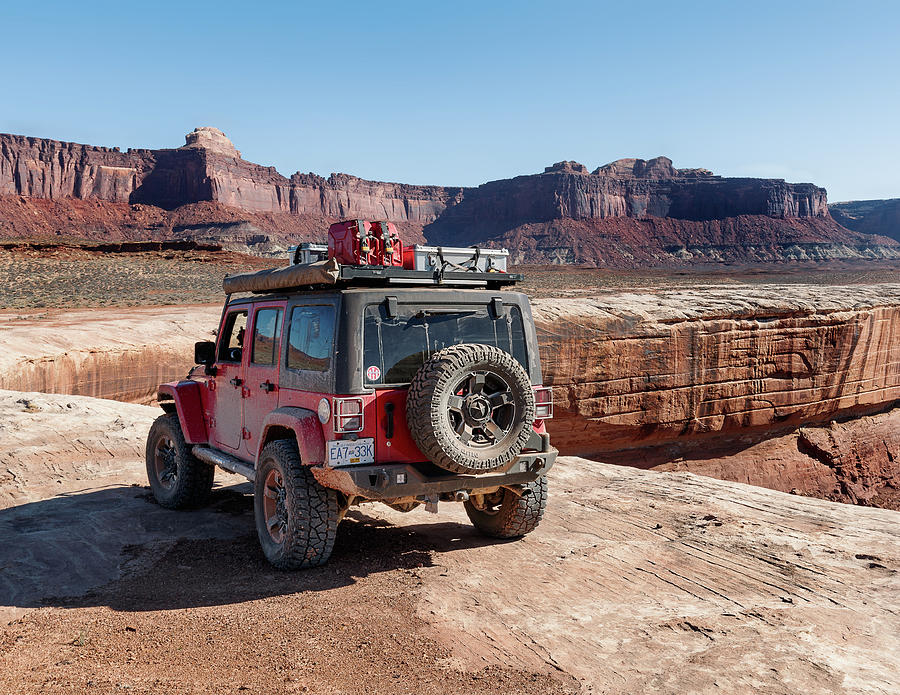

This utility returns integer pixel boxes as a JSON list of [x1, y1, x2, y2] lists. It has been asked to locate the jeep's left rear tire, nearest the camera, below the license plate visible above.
[[253, 439, 340, 570]]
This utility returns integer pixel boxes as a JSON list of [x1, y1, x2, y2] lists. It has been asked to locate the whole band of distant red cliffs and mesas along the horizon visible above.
[[0, 128, 900, 266]]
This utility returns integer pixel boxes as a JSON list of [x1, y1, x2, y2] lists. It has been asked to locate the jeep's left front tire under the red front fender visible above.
[[146, 413, 216, 509]]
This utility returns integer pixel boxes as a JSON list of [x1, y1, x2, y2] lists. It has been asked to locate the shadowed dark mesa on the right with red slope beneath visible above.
[[423, 157, 900, 267]]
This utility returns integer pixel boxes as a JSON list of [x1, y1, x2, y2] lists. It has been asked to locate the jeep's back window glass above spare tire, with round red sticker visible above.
[[363, 304, 528, 386]]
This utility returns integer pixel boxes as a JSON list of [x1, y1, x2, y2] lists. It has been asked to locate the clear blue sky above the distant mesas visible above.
[[0, 0, 900, 201]]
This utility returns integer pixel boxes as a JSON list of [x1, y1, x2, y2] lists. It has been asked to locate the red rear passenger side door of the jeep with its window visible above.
[[243, 301, 285, 458]]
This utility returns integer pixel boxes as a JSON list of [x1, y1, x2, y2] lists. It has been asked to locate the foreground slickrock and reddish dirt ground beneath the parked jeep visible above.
[[0, 391, 900, 694]]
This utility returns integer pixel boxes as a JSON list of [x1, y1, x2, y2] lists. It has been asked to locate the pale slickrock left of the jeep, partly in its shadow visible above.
[[0, 390, 243, 624]]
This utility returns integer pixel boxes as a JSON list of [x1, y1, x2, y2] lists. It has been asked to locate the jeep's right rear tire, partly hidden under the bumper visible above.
[[463, 476, 547, 538]]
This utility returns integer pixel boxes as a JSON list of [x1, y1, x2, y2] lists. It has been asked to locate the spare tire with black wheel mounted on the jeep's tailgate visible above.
[[406, 344, 534, 474]]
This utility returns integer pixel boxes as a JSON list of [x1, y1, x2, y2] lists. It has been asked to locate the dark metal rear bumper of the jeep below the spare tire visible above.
[[310, 446, 559, 500]]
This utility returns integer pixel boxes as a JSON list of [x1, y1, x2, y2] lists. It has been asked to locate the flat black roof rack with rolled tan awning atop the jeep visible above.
[[222, 258, 522, 294]]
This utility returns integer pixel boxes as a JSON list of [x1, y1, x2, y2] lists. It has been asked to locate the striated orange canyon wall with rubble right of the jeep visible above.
[[534, 284, 900, 507]]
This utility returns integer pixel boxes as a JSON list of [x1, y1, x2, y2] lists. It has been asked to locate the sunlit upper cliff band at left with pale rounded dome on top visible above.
[[0, 128, 462, 225]]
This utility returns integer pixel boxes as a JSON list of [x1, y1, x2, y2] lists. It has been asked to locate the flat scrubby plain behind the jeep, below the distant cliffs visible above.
[[0, 242, 900, 309]]
